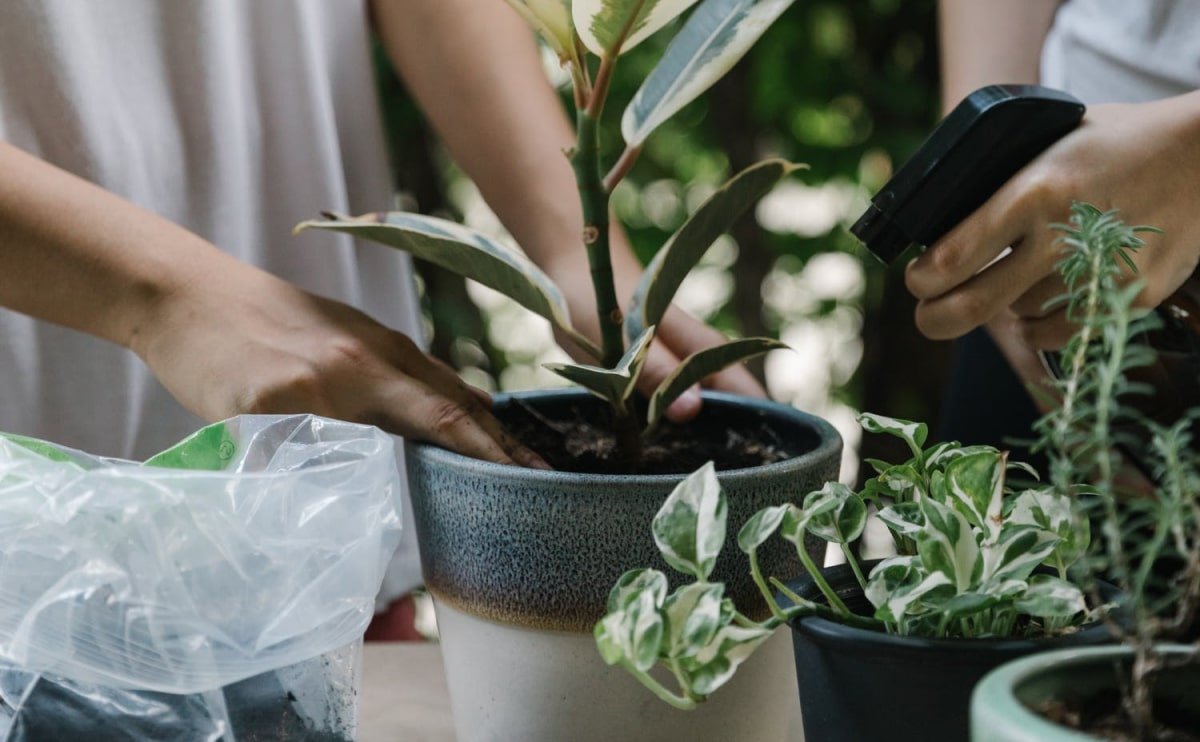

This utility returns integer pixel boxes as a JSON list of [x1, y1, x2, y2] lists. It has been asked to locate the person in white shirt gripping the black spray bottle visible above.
[[906, 0, 1200, 445]]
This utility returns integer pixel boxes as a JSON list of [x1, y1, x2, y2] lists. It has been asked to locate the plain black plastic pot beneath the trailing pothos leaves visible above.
[[792, 562, 1110, 742]]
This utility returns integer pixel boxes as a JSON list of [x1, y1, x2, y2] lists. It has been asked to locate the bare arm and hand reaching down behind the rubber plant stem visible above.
[[373, 0, 761, 419]]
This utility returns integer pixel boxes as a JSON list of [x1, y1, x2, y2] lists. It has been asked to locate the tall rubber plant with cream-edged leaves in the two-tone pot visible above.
[[298, 0, 799, 460]]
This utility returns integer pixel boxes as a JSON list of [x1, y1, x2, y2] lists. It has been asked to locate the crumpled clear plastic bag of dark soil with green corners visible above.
[[0, 415, 401, 741]]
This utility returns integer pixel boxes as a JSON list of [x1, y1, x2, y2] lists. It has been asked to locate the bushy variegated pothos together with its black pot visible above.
[[594, 414, 1106, 741]]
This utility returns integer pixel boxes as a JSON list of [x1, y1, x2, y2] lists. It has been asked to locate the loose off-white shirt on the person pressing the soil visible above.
[[0, 0, 429, 592]]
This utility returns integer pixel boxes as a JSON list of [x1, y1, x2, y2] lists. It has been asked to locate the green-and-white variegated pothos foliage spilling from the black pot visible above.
[[595, 414, 1090, 708]]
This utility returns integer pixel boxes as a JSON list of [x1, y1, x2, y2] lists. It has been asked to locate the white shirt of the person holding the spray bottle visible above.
[[1042, 0, 1200, 103]]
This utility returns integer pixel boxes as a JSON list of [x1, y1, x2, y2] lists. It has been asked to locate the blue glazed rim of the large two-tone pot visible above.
[[406, 389, 842, 486]]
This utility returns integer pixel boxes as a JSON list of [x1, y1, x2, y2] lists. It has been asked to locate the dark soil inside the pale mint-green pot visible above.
[[1033, 689, 1200, 742]]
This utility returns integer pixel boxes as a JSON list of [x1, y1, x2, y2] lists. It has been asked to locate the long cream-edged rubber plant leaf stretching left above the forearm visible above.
[[295, 211, 600, 358]]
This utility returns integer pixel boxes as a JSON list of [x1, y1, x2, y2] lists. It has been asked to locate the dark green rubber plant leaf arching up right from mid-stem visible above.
[[625, 160, 800, 337]]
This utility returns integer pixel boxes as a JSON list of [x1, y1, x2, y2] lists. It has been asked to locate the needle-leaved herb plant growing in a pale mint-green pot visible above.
[[972, 204, 1200, 742]]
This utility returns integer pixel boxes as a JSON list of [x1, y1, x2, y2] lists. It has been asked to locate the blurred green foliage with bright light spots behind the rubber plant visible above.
[[380, 0, 949, 480]]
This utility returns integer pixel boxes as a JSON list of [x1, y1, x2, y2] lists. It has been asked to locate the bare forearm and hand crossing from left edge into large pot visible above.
[[0, 142, 544, 466]]
